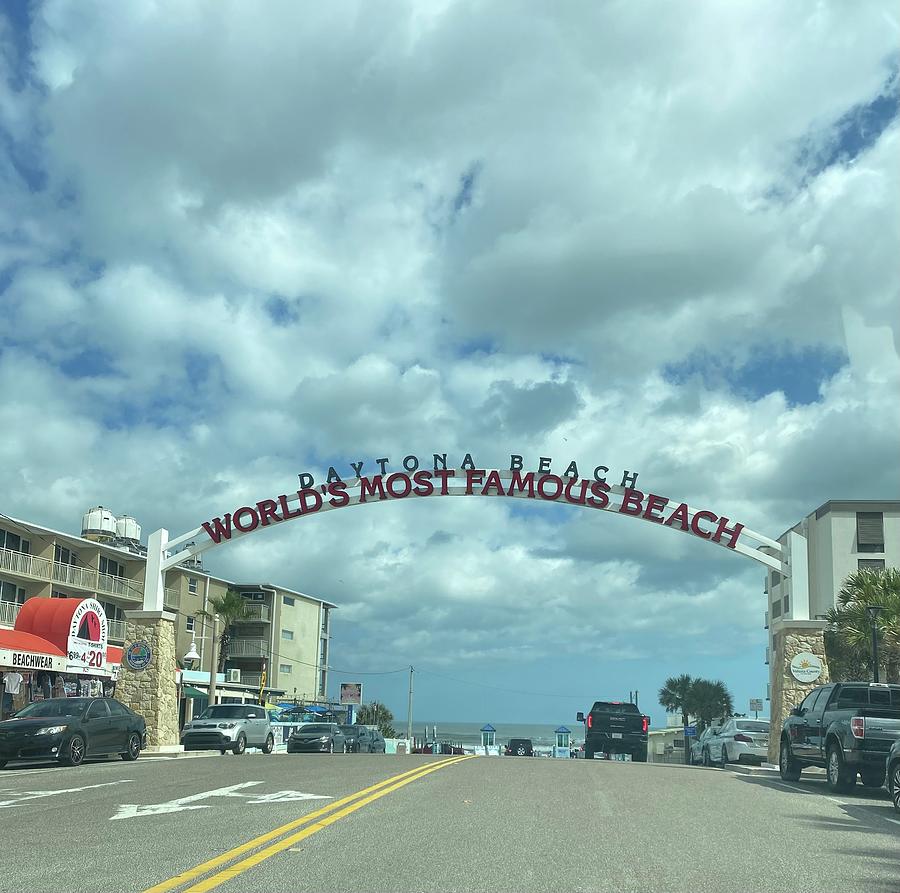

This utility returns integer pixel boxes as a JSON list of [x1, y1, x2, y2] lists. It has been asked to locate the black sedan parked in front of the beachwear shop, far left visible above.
[[0, 698, 147, 769]]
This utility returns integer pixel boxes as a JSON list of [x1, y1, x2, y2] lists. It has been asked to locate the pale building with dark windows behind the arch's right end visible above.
[[765, 500, 900, 692]]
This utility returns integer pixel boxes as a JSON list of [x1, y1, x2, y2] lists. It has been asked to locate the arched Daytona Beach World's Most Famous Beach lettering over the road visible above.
[[202, 453, 744, 549]]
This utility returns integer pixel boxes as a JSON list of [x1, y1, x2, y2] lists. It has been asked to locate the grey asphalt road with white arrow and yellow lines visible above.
[[0, 754, 900, 893]]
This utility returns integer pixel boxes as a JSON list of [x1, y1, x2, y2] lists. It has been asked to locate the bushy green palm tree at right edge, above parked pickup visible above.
[[825, 568, 900, 683]]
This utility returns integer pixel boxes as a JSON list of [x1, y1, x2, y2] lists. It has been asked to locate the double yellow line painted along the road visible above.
[[143, 756, 472, 893]]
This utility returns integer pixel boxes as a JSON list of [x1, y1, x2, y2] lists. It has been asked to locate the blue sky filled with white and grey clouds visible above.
[[0, 0, 900, 722]]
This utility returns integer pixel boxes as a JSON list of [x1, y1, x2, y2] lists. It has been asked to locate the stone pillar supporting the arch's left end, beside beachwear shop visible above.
[[116, 611, 179, 750]]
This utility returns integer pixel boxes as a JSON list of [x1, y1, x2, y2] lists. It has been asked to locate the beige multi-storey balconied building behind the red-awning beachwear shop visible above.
[[0, 508, 335, 700]]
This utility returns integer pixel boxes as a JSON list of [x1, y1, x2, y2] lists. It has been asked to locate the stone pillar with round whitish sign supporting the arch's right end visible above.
[[769, 620, 830, 765]]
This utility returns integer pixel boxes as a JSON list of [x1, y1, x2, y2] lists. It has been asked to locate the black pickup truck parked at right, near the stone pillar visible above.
[[778, 682, 900, 792]]
